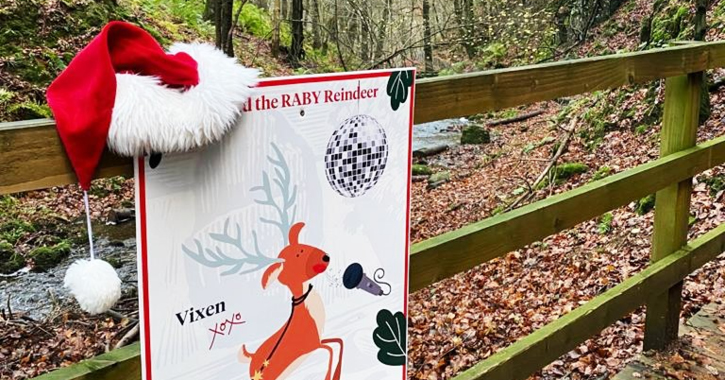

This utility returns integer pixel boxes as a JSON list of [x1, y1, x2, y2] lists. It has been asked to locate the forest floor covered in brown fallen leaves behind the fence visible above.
[[0, 0, 725, 380]]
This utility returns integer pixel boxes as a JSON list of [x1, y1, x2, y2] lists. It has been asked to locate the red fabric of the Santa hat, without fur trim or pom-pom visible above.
[[47, 22, 199, 190]]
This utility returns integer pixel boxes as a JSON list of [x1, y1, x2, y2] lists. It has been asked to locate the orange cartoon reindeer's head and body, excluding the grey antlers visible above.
[[239, 223, 343, 380]]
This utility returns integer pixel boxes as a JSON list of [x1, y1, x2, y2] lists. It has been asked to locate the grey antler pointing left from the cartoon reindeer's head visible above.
[[181, 218, 279, 276]]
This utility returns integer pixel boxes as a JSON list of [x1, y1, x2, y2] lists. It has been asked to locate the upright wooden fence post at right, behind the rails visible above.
[[644, 72, 702, 350]]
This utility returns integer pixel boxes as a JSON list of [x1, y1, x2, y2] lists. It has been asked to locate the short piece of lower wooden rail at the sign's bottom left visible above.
[[35, 342, 141, 380]]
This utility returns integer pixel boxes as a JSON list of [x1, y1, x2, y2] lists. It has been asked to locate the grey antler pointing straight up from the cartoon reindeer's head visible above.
[[251, 143, 297, 246]]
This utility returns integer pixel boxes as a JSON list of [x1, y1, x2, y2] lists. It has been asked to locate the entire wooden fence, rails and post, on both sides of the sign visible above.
[[0, 42, 725, 380]]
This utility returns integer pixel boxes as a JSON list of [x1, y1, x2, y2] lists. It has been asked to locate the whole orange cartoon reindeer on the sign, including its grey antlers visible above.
[[182, 144, 343, 380]]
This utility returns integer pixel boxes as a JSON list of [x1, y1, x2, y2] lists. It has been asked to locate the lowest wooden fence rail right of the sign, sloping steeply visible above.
[[446, 224, 725, 380]]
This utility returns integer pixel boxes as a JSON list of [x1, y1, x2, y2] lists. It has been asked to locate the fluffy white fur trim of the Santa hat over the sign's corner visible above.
[[107, 43, 259, 156]]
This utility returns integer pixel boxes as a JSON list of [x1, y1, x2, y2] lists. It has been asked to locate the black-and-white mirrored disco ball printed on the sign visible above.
[[325, 115, 388, 198]]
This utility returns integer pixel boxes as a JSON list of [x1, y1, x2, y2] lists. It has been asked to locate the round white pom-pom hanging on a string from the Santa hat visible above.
[[64, 259, 121, 314]]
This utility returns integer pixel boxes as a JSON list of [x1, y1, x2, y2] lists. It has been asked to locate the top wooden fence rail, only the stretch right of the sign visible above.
[[415, 42, 725, 123]]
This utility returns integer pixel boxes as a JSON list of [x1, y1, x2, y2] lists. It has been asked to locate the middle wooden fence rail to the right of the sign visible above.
[[410, 136, 725, 291]]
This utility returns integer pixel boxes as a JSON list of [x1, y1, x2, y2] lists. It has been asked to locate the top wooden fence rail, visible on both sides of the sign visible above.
[[0, 42, 725, 194]]
